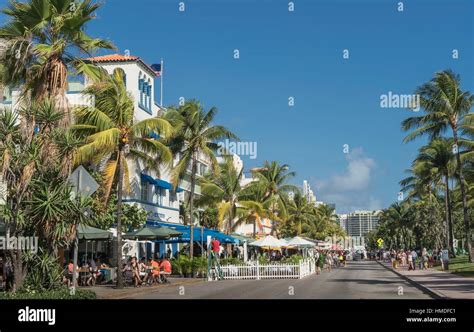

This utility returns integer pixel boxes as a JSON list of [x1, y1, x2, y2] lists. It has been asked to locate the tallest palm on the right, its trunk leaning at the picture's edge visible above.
[[402, 70, 474, 262]]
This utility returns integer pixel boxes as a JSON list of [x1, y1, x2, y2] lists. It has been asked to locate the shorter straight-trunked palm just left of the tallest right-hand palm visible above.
[[415, 138, 456, 255]]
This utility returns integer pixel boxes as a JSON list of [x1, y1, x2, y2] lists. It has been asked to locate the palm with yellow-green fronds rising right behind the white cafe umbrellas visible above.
[[253, 161, 298, 234]]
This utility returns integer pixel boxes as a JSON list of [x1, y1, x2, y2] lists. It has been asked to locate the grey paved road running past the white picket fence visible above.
[[131, 261, 431, 299]]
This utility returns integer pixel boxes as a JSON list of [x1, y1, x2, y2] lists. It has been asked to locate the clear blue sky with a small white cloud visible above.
[[0, 0, 474, 212]]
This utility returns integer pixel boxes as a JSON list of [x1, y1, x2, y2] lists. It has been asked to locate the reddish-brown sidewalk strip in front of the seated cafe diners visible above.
[[90, 278, 204, 300]]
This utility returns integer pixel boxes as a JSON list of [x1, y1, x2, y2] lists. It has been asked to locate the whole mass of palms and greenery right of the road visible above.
[[371, 70, 474, 262]]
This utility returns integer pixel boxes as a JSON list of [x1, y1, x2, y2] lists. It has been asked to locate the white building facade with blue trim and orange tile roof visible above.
[[0, 54, 213, 227]]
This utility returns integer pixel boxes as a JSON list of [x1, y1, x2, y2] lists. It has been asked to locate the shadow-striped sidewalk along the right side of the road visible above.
[[377, 261, 474, 300]]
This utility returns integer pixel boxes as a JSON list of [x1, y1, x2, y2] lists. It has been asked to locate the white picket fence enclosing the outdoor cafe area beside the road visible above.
[[221, 259, 316, 280]]
